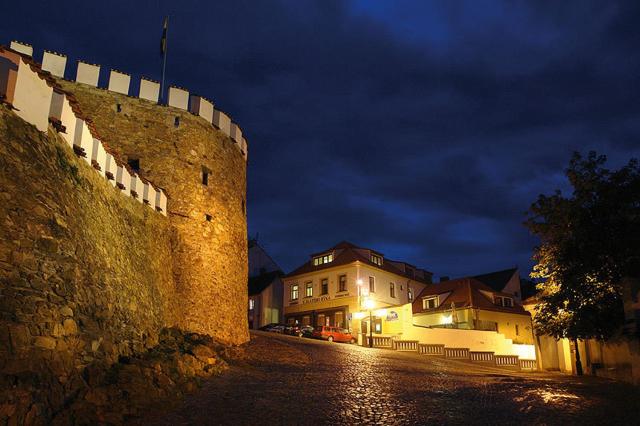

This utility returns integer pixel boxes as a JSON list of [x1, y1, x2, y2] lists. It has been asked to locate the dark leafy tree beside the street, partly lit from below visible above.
[[525, 152, 640, 375]]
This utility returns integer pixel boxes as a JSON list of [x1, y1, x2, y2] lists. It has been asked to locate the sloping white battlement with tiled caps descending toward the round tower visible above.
[[0, 42, 167, 216]]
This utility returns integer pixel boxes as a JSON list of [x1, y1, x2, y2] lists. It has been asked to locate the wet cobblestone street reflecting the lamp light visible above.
[[151, 332, 640, 425]]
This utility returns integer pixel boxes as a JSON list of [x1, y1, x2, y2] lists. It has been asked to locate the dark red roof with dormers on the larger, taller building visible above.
[[285, 241, 432, 283]]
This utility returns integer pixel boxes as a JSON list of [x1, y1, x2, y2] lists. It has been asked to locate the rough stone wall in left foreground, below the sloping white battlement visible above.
[[0, 106, 180, 372]]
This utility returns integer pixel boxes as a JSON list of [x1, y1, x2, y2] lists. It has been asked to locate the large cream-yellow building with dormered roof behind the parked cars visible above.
[[283, 242, 432, 334]]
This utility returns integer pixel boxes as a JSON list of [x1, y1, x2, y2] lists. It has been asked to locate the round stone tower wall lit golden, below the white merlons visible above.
[[53, 80, 248, 343]]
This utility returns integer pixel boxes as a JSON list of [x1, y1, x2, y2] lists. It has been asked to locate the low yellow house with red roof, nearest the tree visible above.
[[412, 273, 533, 344]]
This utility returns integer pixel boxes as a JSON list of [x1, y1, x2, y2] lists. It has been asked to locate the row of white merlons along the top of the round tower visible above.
[[10, 41, 248, 160]]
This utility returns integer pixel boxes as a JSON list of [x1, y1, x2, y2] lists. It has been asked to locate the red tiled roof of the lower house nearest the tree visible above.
[[412, 278, 528, 315]]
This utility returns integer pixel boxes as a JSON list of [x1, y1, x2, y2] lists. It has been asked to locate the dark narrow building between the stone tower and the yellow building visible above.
[[248, 240, 284, 329]]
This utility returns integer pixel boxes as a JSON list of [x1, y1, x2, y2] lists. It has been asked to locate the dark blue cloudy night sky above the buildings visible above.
[[0, 0, 640, 277]]
